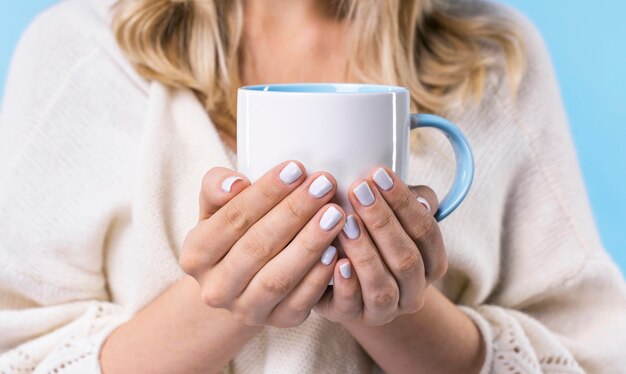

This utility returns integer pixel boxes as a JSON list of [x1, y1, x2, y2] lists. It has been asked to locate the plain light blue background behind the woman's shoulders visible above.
[[0, 0, 626, 270]]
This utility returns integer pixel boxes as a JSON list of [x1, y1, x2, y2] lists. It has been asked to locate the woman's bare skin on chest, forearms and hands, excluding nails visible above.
[[100, 0, 485, 374]]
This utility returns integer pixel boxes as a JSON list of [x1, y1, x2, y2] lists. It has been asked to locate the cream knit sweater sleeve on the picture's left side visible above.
[[0, 1, 144, 373]]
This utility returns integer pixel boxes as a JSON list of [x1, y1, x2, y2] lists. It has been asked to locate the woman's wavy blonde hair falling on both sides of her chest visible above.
[[113, 0, 523, 140]]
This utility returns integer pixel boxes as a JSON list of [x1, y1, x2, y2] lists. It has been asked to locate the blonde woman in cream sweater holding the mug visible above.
[[0, 0, 626, 374]]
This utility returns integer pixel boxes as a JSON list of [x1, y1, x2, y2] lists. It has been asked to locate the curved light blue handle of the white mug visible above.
[[411, 114, 474, 221]]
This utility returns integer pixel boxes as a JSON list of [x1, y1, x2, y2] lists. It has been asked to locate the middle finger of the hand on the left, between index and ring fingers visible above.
[[207, 173, 336, 296]]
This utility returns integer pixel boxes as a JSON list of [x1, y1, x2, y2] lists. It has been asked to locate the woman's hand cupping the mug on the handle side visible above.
[[315, 167, 448, 326]]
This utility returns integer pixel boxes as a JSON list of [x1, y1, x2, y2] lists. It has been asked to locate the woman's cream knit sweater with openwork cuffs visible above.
[[0, 0, 626, 373]]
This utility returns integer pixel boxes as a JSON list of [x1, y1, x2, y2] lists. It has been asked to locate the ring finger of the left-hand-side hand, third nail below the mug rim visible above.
[[234, 204, 345, 319]]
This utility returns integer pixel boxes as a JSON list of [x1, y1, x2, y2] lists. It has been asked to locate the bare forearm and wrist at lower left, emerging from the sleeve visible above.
[[100, 276, 261, 373]]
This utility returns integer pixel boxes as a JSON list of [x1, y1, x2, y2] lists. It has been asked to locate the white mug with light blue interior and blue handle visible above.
[[237, 83, 474, 221]]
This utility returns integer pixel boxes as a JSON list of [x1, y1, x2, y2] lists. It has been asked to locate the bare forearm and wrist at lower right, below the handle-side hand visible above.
[[341, 286, 485, 373]]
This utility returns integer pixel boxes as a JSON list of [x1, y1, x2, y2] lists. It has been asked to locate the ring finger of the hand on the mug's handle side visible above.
[[338, 214, 401, 325]]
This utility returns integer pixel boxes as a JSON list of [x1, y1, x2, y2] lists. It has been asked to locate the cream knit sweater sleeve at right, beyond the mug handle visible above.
[[461, 4, 626, 373]]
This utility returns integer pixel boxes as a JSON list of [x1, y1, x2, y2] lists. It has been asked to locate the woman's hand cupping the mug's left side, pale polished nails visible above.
[[180, 161, 345, 327]]
